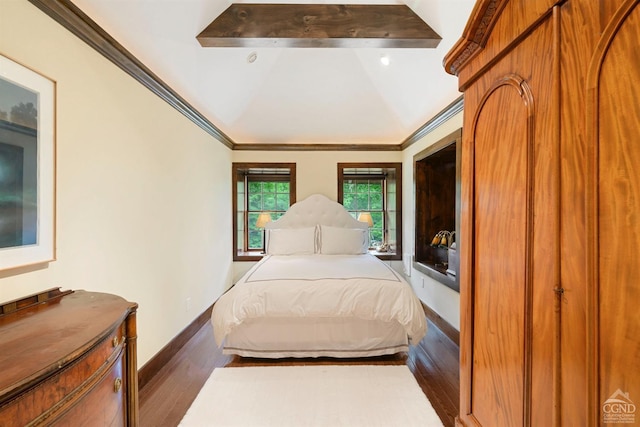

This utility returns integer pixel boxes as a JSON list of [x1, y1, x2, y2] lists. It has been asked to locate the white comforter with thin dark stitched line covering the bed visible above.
[[212, 254, 427, 345]]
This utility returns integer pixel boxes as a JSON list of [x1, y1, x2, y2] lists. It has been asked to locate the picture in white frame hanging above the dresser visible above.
[[0, 55, 55, 270]]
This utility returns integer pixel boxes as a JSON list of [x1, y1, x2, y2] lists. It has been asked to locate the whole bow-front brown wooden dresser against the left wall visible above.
[[0, 288, 138, 427]]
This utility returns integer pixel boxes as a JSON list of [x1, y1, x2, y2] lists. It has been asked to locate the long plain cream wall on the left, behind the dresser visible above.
[[0, 0, 232, 366]]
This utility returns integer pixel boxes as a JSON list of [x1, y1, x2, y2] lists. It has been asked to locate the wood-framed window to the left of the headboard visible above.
[[233, 163, 296, 261]]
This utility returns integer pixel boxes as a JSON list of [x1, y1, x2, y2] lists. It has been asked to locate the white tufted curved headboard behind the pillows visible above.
[[265, 194, 368, 229]]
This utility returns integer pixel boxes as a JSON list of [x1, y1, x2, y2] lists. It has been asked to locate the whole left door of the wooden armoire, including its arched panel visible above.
[[458, 5, 559, 427]]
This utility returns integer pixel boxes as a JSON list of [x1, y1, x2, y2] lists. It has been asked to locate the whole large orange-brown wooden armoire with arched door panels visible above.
[[444, 0, 640, 427]]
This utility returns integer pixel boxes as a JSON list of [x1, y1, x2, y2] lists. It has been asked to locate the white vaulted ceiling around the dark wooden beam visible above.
[[73, 0, 475, 144]]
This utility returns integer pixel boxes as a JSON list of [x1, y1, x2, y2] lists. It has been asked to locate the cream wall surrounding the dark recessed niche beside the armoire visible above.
[[402, 112, 462, 330]]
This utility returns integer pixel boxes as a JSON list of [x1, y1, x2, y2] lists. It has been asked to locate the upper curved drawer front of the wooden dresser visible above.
[[0, 324, 125, 426]]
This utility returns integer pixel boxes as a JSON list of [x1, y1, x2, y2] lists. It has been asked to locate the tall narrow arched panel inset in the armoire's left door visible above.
[[471, 78, 531, 426]]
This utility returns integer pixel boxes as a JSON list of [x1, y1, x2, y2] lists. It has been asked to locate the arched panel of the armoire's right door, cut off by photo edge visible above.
[[585, 0, 640, 425]]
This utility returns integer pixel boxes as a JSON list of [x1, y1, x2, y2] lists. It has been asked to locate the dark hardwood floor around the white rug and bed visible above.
[[139, 322, 460, 427]]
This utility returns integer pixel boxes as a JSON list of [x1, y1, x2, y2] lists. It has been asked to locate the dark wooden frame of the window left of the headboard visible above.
[[231, 162, 296, 261]]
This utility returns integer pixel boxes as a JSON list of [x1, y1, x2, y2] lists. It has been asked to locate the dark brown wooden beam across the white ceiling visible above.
[[196, 3, 442, 48]]
